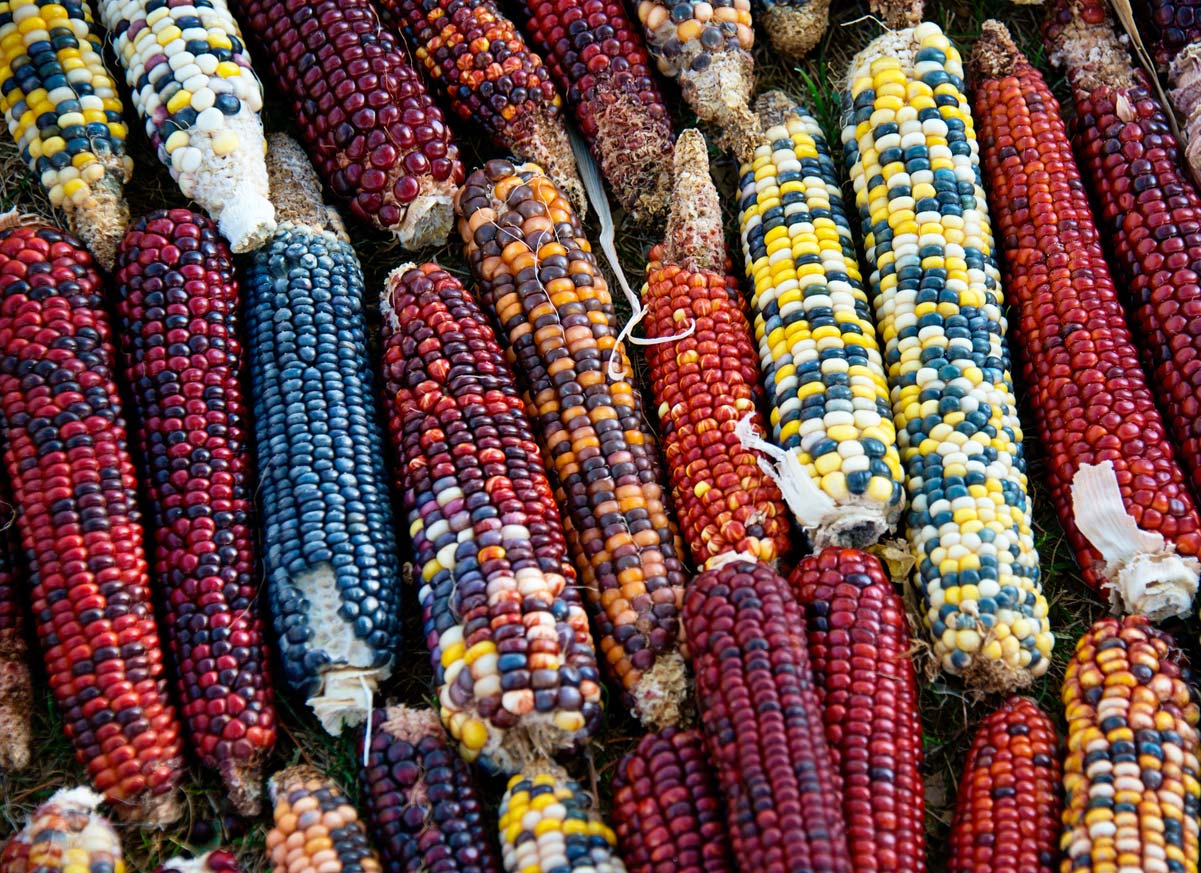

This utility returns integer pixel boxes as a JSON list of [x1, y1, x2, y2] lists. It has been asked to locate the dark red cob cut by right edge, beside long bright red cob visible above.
[[1044, 0, 1201, 511]]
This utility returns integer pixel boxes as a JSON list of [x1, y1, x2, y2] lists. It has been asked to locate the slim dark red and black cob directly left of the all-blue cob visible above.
[[115, 209, 275, 815]]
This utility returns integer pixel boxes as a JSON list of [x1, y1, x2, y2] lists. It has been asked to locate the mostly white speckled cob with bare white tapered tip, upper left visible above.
[[98, 0, 275, 252]]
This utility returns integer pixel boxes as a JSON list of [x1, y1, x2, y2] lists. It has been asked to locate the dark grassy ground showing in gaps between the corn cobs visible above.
[[0, 0, 1124, 873]]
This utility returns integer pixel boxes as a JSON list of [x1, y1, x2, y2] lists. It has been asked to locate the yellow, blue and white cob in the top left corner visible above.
[[0, 0, 133, 269]]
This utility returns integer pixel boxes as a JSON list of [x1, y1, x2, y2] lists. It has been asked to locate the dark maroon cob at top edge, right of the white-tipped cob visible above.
[[234, 0, 462, 249]]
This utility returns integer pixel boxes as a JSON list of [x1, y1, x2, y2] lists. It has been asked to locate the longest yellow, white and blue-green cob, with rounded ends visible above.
[[843, 23, 1054, 690]]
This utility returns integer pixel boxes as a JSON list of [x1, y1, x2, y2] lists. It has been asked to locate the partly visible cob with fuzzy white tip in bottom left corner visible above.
[[0, 788, 125, 873]]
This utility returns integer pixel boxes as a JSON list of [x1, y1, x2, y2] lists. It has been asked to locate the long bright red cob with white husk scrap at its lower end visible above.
[[974, 22, 1201, 620]]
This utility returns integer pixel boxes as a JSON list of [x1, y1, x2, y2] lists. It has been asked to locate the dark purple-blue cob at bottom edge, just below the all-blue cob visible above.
[[360, 706, 501, 873]]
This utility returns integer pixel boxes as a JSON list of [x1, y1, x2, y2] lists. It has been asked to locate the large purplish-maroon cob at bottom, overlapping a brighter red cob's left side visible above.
[[683, 560, 855, 873]]
